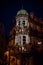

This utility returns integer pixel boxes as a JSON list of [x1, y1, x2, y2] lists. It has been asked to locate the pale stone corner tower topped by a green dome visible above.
[[15, 9, 30, 50]]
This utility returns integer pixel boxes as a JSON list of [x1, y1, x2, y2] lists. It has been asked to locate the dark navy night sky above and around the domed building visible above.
[[0, 0, 43, 35]]
